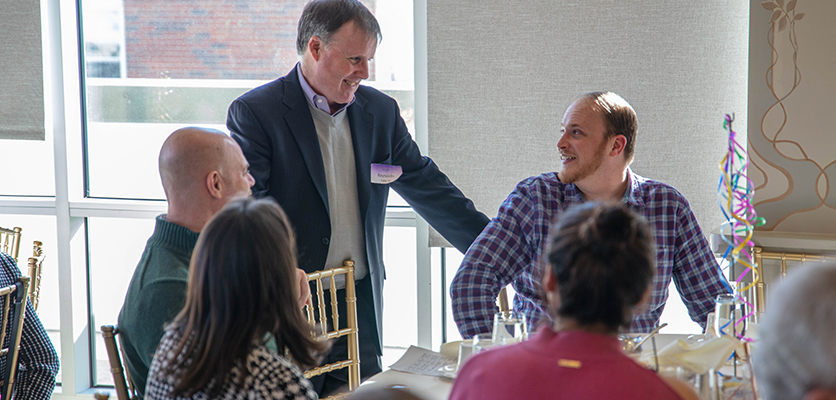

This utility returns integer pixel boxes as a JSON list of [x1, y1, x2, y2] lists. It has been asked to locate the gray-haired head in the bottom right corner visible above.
[[753, 264, 836, 400]]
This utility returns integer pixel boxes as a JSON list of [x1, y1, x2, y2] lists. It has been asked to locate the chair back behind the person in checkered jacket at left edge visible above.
[[0, 276, 29, 399]]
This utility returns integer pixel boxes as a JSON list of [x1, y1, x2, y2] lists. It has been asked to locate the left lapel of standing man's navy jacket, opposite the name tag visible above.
[[283, 65, 330, 214]]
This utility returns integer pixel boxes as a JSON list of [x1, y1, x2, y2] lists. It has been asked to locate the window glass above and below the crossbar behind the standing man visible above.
[[80, 0, 416, 385]]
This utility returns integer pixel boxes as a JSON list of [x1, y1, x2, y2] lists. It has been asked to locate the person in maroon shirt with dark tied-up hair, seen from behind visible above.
[[450, 203, 698, 400]]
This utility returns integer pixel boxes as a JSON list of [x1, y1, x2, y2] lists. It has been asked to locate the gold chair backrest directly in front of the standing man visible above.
[[305, 260, 360, 391]]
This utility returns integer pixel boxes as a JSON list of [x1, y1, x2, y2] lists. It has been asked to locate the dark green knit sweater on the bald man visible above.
[[119, 215, 199, 396]]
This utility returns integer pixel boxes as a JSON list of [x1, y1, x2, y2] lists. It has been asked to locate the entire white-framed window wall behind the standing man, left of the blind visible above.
[[0, 0, 429, 399]]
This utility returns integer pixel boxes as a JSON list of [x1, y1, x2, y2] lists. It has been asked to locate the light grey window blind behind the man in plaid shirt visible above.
[[427, 0, 748, 245]]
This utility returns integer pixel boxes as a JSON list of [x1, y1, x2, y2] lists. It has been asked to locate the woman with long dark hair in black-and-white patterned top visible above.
[[145, 199, 325, 399]]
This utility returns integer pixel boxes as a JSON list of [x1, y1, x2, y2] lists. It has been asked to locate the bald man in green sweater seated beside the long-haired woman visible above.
[[119, 127, 310, 397]]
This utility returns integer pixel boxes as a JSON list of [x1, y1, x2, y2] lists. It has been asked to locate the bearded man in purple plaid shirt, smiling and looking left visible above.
[[450, 92, 730, 338]]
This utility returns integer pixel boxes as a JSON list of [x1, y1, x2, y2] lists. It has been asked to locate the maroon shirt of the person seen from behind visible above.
[[450, 328, 681, 400]]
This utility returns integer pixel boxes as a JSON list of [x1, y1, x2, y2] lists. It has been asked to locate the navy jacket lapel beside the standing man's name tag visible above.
[[346, 93, 374, 223]]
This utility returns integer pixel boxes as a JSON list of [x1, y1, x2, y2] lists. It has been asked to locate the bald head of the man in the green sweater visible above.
[[159, 127, 254, 231]]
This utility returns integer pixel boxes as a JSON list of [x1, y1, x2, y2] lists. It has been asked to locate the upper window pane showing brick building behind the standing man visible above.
[[81, 0, 414, 199]]
